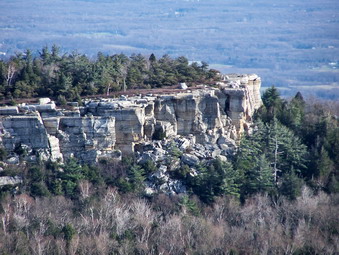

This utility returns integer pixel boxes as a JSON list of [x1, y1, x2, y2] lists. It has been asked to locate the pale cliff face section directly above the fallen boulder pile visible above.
[[154, 90, 227, 142]]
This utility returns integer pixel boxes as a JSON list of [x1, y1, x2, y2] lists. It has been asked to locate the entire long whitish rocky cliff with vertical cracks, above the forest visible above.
[[0, 75, 261, 162]]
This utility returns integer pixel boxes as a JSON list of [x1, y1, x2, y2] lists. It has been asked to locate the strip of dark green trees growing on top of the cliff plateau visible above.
[[0, 45, 217, 101]]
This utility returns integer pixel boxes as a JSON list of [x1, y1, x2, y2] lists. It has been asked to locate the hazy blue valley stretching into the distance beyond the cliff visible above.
[[0, 0, 339, 99]]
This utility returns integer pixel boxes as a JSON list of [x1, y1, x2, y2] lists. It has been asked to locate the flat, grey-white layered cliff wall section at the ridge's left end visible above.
[[1, 114, 115, 163]]
